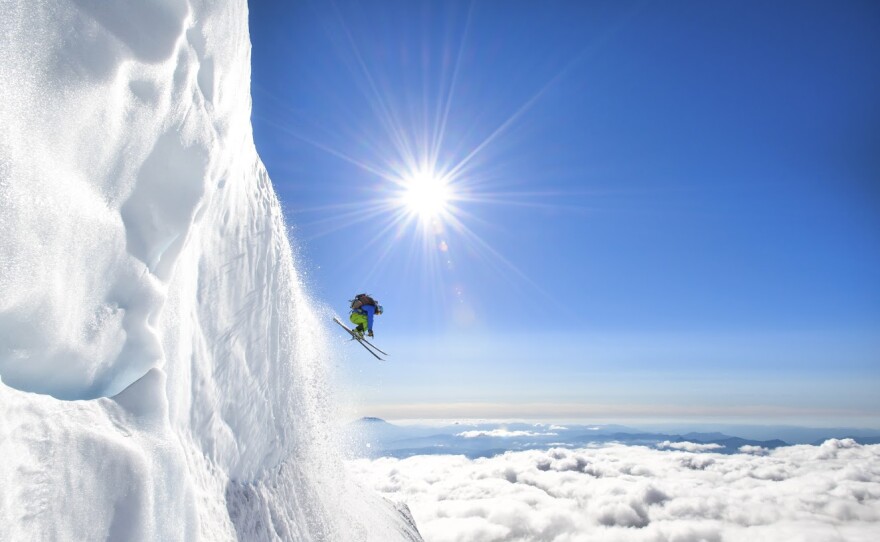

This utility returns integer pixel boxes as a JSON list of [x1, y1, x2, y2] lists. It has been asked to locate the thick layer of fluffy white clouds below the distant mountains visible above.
[[349, 439, 880, 542]]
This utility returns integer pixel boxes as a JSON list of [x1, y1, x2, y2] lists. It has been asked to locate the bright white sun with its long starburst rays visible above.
[[261, 1, 648, 326]]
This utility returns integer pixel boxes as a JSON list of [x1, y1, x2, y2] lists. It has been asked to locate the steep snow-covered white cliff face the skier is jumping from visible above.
[[0, 0, 419, 541]]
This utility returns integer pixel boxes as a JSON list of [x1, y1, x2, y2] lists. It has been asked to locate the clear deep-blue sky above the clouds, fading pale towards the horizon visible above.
[[250, 0, 880, 426]]
